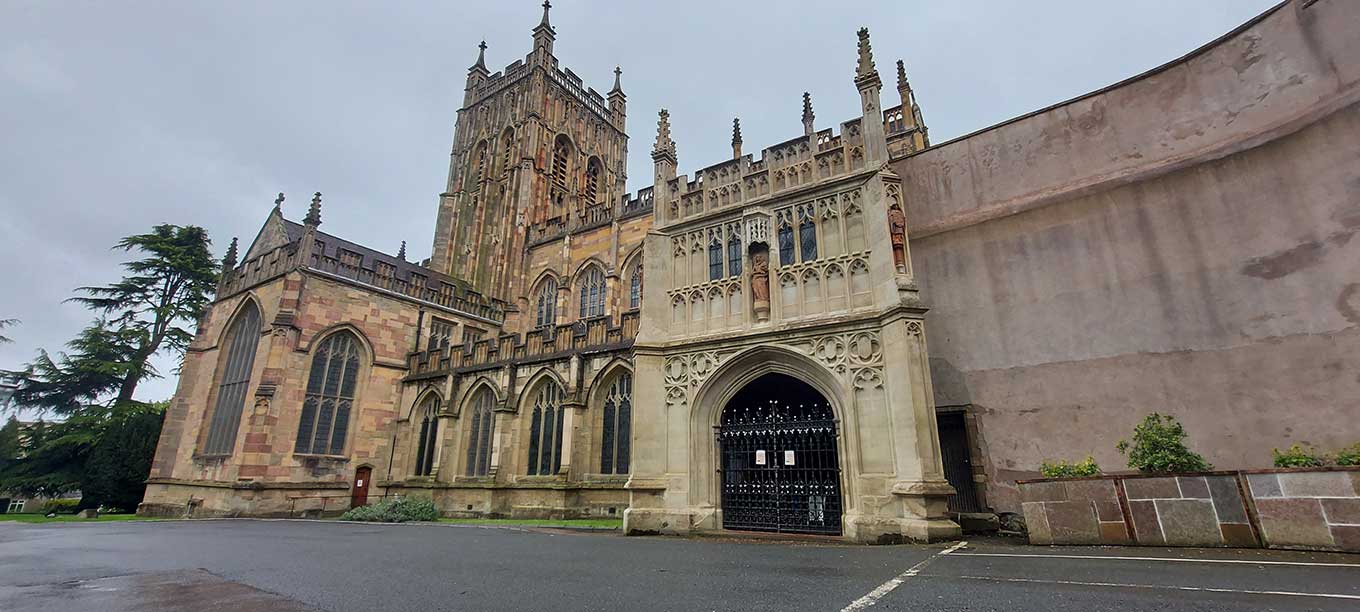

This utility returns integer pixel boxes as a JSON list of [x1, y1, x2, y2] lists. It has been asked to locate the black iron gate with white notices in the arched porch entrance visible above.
[[718, 401, 842, 536]]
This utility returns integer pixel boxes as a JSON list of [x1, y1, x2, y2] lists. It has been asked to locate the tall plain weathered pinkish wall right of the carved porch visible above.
[[894, 0, 1360, 510]]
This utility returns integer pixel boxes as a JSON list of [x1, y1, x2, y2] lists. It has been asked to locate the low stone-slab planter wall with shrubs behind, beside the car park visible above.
[[1016, 468, 1360, 552]]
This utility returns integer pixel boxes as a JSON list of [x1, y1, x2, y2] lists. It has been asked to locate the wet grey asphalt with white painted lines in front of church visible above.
[[0, 520, 1360, 612]]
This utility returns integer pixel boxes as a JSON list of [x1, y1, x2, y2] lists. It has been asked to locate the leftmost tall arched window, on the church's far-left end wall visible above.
[[203, 301, 260, 454]]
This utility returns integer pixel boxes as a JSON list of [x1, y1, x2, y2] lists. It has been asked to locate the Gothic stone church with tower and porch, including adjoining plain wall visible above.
[[140, 0, 1360, 543]]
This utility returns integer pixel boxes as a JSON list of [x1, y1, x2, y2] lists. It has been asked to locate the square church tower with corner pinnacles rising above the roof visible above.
[[430, 1, 628, 320]]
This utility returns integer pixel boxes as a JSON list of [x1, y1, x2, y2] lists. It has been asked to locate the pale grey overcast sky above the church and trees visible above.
[[0, 0, 1274, 400]]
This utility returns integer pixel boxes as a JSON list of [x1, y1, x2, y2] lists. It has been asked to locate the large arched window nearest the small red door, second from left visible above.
[[294, 332, 360, 454]]
